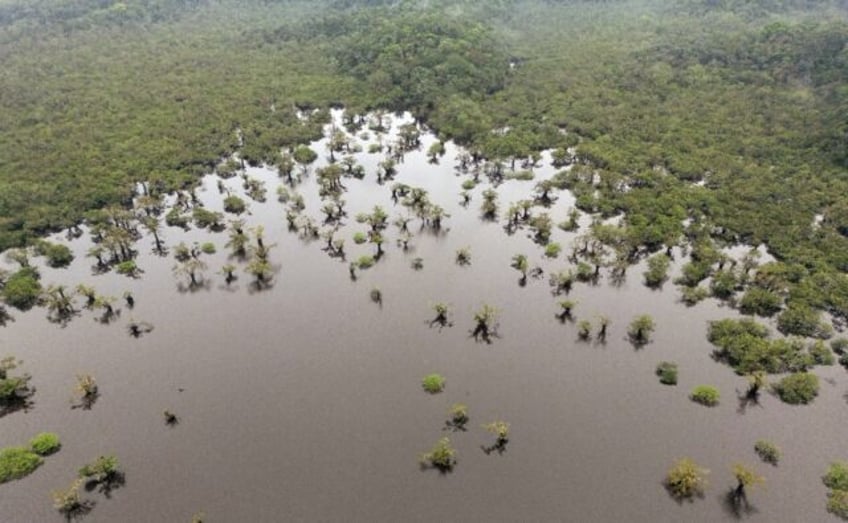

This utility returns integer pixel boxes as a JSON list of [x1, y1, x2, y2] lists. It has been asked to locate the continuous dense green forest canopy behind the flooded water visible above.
[[0, 0, 848, 326]]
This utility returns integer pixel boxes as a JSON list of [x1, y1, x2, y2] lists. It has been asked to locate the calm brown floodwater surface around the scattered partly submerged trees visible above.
[[0, 111, 848, 523]]
